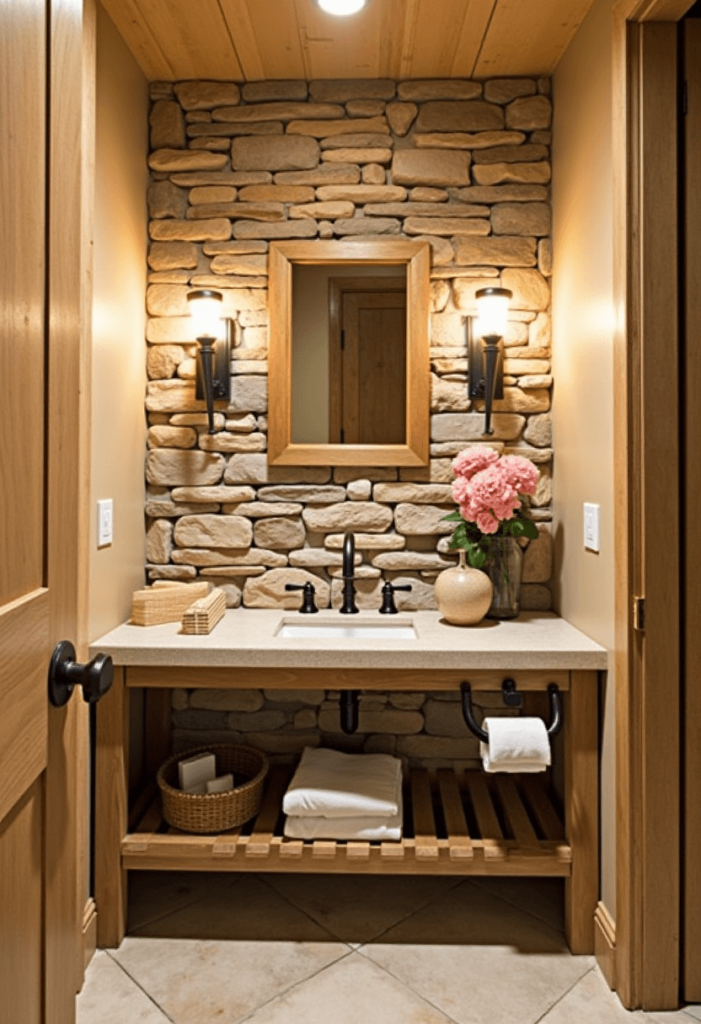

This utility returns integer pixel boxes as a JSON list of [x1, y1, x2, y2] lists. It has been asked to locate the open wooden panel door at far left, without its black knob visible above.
[[0, 0, 90, 1024]]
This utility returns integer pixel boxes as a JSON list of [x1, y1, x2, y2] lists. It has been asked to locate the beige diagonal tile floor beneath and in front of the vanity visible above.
[[78, 871, 701, 1024]]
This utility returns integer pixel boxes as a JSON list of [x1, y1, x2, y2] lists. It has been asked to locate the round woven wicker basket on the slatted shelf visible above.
[[157, 743, 268, 833]]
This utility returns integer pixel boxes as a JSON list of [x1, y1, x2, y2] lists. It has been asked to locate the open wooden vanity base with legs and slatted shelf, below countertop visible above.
[[95, 667, 599, 953]]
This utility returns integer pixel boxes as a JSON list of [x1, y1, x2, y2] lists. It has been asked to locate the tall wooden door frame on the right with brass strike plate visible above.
[[612, 0, 692, 1010]]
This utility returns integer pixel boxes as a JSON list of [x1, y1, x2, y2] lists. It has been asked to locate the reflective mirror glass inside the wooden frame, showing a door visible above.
[[292, 264, 406, 444]]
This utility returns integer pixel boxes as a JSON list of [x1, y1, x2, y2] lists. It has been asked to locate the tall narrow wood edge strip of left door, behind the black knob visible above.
[[44, 0, 96, 1011]]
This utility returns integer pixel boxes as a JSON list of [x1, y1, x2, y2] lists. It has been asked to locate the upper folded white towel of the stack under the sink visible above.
[[282, 746, 401, 818]]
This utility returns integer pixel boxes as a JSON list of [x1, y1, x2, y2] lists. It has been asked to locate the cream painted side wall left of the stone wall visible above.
[[89, 4, 148, 639]]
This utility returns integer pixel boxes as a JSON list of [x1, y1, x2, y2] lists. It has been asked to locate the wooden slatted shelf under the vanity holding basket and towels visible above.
[[122, 768, 572, 877]]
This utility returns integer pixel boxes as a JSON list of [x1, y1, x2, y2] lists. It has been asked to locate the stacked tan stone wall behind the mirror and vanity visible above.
[[146, 79, 553, 770]]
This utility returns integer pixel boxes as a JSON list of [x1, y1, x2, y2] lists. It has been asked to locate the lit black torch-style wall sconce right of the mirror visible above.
[[468, 288, 513, 434]]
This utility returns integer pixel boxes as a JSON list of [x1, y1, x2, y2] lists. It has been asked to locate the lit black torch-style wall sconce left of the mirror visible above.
[[187, 288, 231, 434]]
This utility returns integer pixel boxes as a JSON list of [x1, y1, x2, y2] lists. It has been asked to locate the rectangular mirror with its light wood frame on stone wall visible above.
[[268, 239, 431, 466]]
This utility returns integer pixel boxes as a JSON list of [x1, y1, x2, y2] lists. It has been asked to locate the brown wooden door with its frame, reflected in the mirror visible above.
[[328, 278, 406, 444]]
